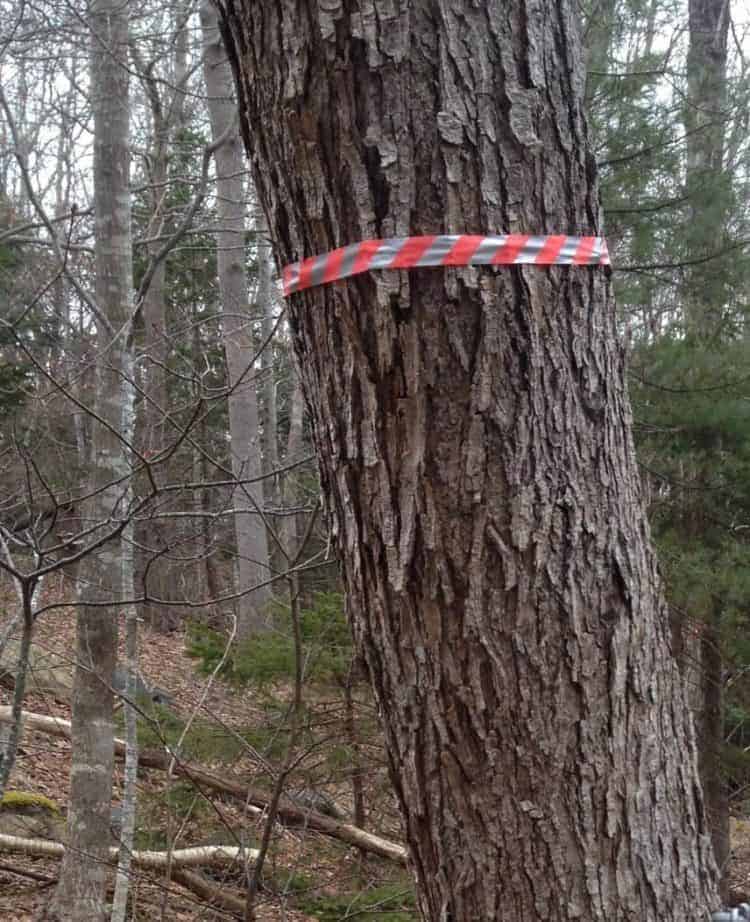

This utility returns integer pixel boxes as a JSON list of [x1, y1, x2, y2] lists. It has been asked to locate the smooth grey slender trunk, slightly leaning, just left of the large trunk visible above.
[[201, 3, 269, 641]]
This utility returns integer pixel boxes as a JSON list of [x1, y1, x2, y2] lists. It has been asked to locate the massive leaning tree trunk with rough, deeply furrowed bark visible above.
[[214, 0, 716, 922]]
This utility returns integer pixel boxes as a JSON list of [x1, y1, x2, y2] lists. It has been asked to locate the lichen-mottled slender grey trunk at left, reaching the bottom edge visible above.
[[49, 0, 132, 922]]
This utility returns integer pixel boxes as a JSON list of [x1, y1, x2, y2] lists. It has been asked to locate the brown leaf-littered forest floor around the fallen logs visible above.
[[0, 580, 750, 922]]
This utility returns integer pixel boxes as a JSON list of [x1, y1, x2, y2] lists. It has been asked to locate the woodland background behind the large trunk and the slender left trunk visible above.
[[0, 0, 750, 922]]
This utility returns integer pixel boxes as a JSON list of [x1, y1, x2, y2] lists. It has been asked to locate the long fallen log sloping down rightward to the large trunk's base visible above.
[[0, 706, 408, 864]]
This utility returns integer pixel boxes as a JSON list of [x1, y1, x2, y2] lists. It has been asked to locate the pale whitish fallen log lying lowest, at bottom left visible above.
[[0, 834, 258, 871]]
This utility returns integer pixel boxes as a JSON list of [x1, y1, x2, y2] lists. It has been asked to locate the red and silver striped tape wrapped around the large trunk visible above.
[[282, 234, 610, 298]]
